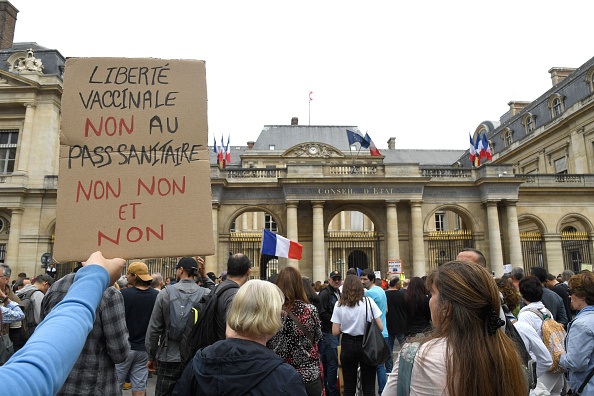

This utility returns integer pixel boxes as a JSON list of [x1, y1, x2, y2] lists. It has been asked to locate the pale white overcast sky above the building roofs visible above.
[[9, 0, 594, 150]]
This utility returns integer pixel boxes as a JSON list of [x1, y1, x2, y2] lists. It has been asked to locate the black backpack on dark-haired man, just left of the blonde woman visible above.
[[179, 282, 239, 366]]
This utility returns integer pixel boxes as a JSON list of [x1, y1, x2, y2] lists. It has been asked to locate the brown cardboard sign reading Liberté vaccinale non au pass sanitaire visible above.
[[54, 58, 214, 261]]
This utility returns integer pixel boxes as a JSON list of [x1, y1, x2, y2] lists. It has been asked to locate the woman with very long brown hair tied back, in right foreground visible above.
[[384, 261, 528, 396]]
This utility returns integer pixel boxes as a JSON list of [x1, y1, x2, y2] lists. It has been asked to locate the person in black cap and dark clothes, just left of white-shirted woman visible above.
[[319, 270, 342, 396]]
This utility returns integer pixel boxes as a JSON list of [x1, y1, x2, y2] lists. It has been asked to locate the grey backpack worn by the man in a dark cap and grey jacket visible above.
[[165, 285, 208, 341]]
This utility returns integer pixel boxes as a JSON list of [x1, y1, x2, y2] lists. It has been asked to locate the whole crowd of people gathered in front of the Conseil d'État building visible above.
[[0, 249, 594, 396]]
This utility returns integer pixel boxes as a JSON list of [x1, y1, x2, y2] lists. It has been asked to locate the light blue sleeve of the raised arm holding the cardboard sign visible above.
[[0, 265, 109, 395]]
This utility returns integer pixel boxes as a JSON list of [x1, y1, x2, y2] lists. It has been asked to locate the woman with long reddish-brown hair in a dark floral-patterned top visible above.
[[266, 267, 322, 396]]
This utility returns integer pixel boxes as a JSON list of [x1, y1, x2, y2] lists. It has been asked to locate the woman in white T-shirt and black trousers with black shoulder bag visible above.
[[331, 275, 384, 396]]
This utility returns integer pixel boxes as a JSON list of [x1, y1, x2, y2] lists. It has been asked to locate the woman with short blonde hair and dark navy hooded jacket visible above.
[[173, 280, 306, 396]]
